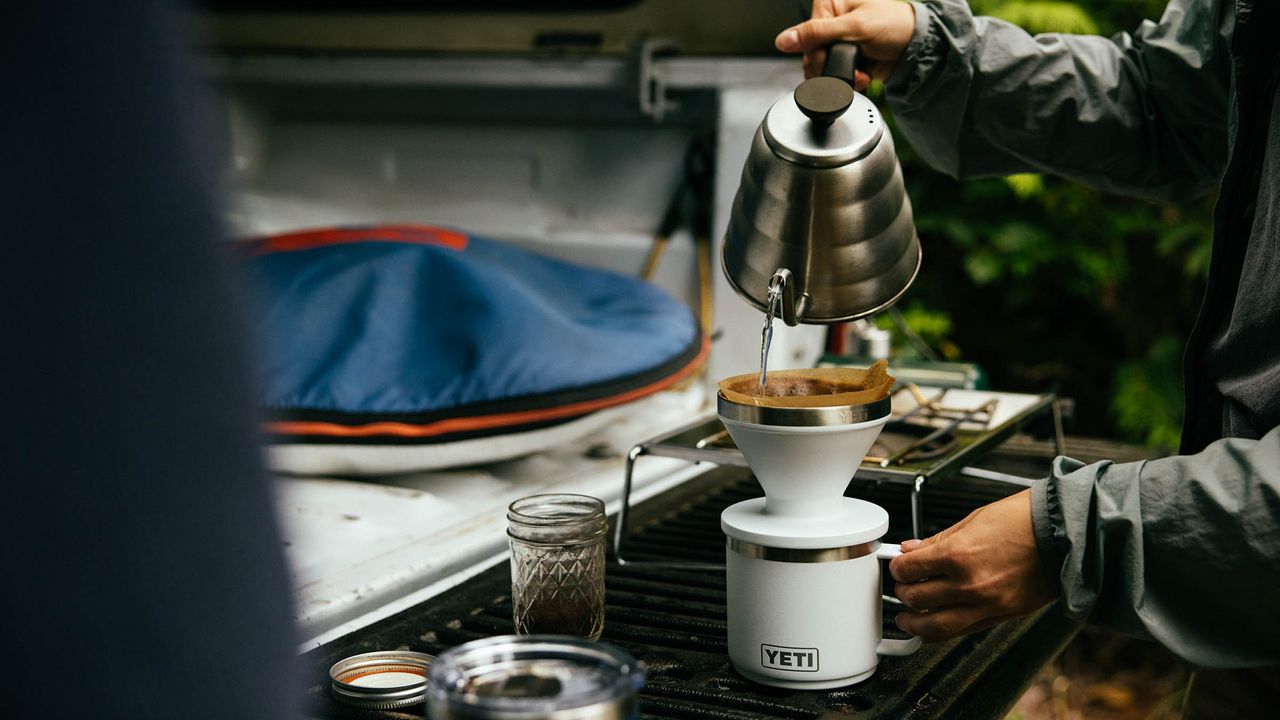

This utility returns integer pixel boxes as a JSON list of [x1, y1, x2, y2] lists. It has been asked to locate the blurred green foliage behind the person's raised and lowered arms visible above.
[[872, 0, 1213, 450]]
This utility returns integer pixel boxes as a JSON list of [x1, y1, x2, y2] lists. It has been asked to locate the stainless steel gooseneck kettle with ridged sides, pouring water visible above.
[[722, 44, 920, 325]]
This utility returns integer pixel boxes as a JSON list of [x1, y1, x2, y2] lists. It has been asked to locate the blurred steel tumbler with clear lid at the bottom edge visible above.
[[426, 635, 644, 720]]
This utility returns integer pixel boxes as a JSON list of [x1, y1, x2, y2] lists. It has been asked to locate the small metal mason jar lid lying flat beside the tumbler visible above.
[[329, 650, 434, 710]]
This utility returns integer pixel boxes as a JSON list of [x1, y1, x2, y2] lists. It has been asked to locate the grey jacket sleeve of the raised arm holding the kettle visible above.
[[886, 0, 1233, 200]]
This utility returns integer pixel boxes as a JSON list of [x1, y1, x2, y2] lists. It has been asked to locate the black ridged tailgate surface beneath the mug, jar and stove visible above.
[[296, 430, 1152, 720]]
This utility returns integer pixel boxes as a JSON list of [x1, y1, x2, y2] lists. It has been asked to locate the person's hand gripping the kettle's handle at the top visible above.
[[774, 0, 915, 90]]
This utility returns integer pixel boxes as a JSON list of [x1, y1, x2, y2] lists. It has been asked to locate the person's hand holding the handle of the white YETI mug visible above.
[[888, 489, 1059, 641]]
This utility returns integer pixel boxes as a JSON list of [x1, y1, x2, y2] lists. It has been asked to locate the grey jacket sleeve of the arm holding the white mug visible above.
[[1032, 428, 1280, 667]]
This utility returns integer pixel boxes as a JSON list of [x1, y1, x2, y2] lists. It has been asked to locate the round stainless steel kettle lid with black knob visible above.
[[762, 77, 884, 168]]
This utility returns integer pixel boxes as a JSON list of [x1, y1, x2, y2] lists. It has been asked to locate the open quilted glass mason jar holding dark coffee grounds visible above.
[[507, 495, 608, 641]]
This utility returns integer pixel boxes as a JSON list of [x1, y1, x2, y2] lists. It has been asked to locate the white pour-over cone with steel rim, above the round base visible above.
[[719, 396, 890, 518]]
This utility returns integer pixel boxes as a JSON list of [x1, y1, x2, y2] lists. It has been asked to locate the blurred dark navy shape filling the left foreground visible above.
[[0, 0, 297, 720]]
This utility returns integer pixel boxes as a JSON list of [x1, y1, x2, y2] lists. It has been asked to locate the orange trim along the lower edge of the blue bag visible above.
[[266, 336, 710, 437]]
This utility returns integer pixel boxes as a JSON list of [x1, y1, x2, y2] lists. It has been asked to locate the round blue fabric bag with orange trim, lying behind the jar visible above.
[[241, 225, 707, 443]]
